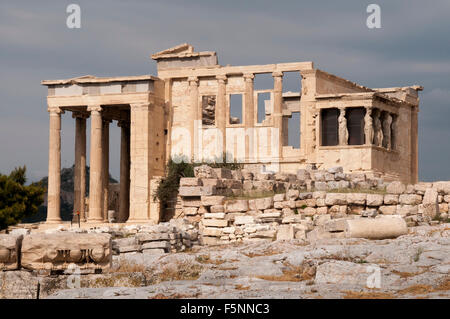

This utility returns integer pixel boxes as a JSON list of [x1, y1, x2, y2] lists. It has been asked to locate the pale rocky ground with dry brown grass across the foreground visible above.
[[0, 224, 450, 299]]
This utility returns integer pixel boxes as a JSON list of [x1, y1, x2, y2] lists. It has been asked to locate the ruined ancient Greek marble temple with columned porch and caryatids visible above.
[[42, 44, 423, 223]]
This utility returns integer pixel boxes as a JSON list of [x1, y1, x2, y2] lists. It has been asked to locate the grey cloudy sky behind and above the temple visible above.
[[0, 0, 450, 181]]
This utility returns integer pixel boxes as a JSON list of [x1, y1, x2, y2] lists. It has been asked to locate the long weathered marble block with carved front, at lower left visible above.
[[21, 233, 112, 270]]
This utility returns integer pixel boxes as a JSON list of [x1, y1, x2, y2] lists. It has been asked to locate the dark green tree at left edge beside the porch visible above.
[[0, 166, 45, 230]]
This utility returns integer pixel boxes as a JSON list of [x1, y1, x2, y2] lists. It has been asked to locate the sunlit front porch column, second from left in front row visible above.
[[88, 105, 103, 222]]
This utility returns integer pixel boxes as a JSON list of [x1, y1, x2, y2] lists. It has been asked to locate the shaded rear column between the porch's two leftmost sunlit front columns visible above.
[[72, 112, 87, 222]]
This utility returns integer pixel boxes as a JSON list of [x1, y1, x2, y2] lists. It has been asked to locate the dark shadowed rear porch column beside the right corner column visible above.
[[117, 121, 130, 223]]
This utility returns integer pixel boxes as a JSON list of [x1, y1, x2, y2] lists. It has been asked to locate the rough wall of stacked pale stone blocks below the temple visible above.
[[179, 166, 450, 244]]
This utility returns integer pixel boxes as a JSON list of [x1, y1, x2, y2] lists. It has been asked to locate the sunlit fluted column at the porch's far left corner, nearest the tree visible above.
[[47, 108, 62, 223]]
